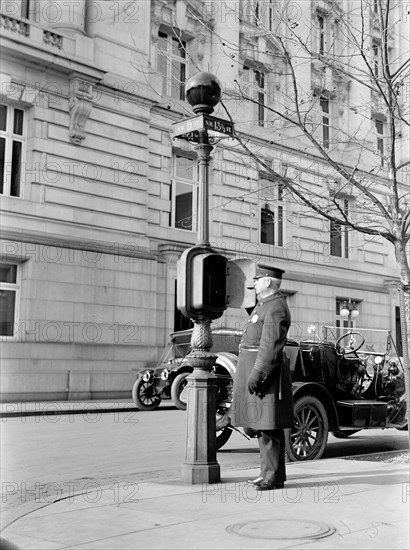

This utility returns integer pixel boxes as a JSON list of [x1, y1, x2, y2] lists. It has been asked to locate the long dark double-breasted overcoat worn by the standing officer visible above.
[[230, 291, 293, 430]]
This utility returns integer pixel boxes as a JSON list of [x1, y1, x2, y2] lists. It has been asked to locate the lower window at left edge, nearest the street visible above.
[[0, 263, 19, 336]]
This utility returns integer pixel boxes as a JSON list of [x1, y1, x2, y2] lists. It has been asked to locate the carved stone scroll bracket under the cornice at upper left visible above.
[[70, 78, 93, 145]]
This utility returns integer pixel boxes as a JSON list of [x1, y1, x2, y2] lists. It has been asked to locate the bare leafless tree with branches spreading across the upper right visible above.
[[210, 0, 410, 420]]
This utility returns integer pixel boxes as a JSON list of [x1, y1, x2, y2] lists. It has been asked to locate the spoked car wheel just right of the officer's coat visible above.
[[285, 395, 329, 462]]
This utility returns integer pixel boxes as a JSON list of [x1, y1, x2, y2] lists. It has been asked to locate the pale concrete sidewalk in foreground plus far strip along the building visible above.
[[0, 401, 410, 550]]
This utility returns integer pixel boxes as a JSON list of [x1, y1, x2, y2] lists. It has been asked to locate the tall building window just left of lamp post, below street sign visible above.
[[171, 155, 198, 231]]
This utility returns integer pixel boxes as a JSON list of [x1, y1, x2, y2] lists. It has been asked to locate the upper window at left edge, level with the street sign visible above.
[[0, 105, 25, 197]]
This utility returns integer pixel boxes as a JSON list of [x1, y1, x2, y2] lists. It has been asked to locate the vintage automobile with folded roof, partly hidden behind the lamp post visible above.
[[132, 328, 242, 414]]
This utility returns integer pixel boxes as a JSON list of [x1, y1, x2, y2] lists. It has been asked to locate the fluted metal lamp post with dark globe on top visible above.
[[178, 73, 221, 484]]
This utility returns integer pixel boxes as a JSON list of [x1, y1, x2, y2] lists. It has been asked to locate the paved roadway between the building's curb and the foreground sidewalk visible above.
[[1, 403, 408, 527]]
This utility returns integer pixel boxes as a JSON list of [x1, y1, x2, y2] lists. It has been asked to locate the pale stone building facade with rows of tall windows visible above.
[[0, 0, 406, 401]]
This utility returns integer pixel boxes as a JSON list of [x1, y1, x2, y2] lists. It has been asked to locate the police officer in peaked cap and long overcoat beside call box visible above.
[[229, 264, 293, 491]]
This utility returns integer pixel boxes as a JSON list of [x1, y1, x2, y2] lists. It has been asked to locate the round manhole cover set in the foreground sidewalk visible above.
[[226, 519, 336, 540]]
